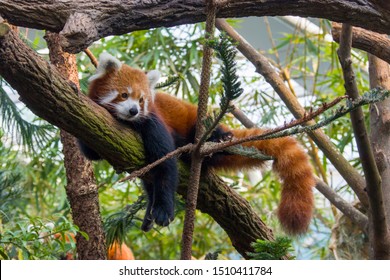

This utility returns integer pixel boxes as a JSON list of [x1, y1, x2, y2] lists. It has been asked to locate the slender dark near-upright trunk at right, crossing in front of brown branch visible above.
[[337, 24, 390, 259]]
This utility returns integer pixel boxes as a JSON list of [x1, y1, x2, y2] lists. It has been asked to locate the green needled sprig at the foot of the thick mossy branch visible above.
[[248, 237, 294, 260]]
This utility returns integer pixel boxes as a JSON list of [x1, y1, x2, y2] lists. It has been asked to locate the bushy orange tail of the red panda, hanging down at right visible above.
[[212, 128, 315, 235]]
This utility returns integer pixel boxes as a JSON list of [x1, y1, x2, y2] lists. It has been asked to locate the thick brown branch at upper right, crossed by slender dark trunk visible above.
[[332, 22, 390, 63]]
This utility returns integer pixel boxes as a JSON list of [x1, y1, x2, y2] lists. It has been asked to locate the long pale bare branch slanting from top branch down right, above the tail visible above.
[[216, 19, 368, 207]]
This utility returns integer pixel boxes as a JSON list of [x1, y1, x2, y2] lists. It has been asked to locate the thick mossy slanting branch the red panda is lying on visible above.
[[0, 18, 272, 256]]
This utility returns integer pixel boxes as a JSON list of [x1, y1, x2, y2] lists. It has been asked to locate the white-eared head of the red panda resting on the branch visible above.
[[89, 53, 160, 121]]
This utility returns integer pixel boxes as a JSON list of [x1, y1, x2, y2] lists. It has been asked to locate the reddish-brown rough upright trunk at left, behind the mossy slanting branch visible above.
[[45, 32, 107, 260]]
